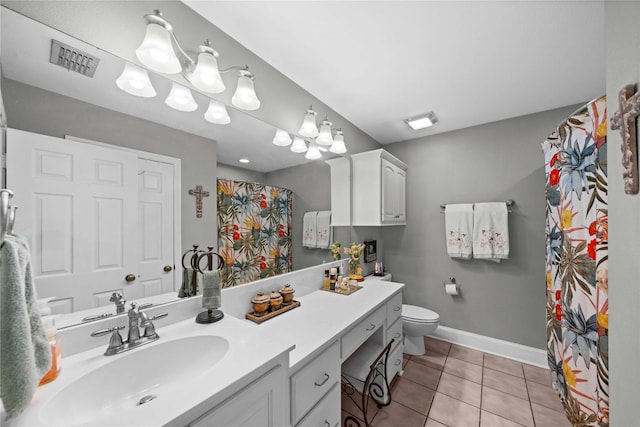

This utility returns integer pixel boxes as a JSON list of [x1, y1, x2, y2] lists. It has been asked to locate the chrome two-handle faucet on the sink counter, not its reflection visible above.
[[91, 302, 168, 356]]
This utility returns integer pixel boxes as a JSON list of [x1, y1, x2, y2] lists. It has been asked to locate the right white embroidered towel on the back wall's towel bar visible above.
[[473, 202, 509, 262]]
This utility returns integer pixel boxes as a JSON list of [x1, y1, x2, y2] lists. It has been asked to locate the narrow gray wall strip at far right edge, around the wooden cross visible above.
[[605, 1, 640, 426]]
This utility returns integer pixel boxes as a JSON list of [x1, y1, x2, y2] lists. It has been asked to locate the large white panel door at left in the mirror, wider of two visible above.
[[7, 129, 142, 312]]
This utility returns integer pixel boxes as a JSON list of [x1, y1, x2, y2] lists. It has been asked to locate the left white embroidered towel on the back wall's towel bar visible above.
[[444, 203, 473, 259]]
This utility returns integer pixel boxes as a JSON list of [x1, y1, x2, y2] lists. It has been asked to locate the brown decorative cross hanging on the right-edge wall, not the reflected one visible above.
[[611, 84, 640, 194]]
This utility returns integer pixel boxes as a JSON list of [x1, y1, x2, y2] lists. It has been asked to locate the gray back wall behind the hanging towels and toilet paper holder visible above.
[[382, 104, 588, 349]]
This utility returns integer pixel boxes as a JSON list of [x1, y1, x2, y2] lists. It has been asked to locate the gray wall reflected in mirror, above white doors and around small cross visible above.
[[2, 79, 217, 254]]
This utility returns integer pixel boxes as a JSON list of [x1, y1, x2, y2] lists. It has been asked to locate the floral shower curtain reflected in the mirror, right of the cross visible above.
[[217, 179, 293, 288]]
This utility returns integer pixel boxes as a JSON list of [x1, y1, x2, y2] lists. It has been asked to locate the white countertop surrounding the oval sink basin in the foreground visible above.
[[7, 316, 294, 427]]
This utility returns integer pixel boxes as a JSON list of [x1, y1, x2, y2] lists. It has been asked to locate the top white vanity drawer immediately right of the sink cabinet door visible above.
[[291, 342, 340, 424]]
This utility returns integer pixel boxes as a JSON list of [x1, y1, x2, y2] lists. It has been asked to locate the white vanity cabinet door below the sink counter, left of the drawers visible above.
[[189, 366, 287, 427]]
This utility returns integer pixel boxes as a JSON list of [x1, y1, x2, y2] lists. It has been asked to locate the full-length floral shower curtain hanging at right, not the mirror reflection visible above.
[[542, 97, 609, 426]]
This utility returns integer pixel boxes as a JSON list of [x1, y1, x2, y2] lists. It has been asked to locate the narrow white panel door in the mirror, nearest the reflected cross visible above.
[[137, 158, 175, 297]]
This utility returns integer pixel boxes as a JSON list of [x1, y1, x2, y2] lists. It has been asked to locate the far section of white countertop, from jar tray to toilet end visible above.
[[238, 280, 404, 374]]
